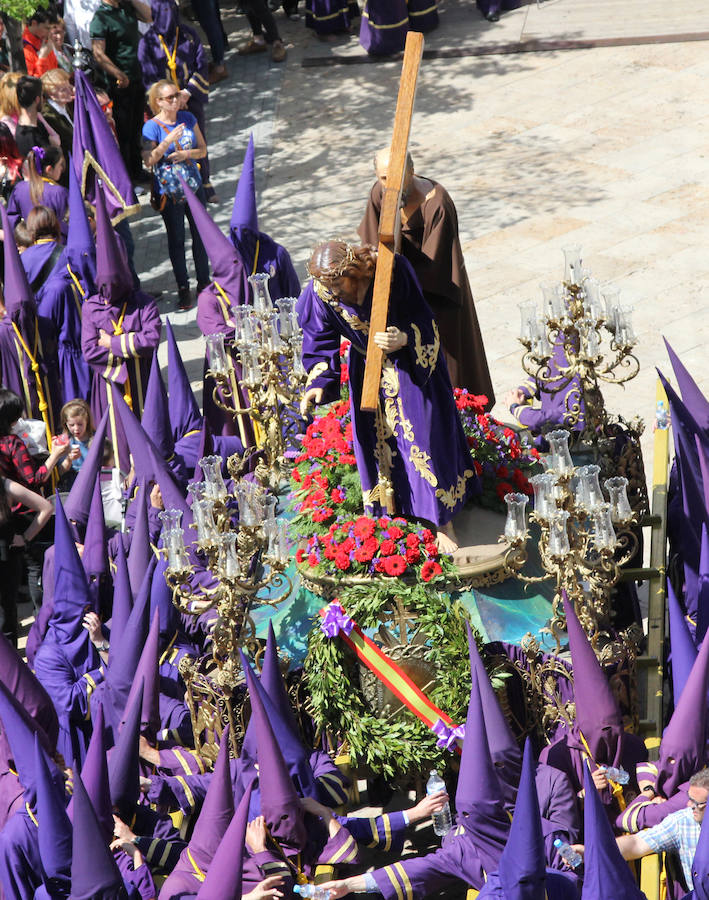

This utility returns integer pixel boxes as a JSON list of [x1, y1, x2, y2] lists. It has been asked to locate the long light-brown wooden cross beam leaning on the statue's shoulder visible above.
[[360, 31, 423, 412]]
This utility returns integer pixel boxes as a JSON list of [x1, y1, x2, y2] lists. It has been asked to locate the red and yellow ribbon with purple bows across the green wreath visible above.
[[320, 600, 464, 753]]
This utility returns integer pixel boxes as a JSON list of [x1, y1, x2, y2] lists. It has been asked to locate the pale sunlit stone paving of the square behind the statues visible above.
[[134, 0, 709, 478]]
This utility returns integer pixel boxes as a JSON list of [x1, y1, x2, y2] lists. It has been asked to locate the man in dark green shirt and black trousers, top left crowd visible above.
[[90, 0, 152, 183]]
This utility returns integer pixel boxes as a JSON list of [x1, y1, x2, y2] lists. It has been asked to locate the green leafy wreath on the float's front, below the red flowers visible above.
[[305, 582, 480, 778]]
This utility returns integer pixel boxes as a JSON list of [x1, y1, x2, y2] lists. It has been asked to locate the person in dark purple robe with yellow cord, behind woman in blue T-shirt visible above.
[[138, 0, 217, 203]]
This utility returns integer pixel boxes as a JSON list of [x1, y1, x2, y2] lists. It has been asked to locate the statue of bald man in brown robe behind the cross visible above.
[[359, 148, 495, 408]]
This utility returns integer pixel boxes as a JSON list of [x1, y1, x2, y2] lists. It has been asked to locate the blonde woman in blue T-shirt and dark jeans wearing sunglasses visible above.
[[143, 79, 210, 309]]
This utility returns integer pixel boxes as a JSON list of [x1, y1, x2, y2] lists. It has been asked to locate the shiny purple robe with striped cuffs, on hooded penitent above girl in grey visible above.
[[81, 291, 162, 422]]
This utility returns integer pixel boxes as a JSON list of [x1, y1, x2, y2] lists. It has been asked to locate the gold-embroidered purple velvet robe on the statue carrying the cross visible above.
[[298, 256, 479, 525]]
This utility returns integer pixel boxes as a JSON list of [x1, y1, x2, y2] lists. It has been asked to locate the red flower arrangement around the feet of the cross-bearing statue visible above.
[[291, 342, 536, 582]]
